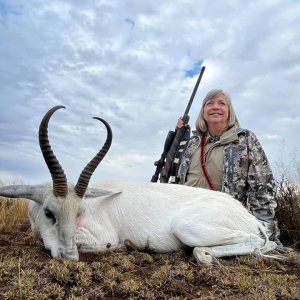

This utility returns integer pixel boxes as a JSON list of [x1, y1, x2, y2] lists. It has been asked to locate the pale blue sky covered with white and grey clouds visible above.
[[0, 0, 300, 184]]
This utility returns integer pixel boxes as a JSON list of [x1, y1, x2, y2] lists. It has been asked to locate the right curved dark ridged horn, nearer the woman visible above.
[[75, 117, 112, 198]]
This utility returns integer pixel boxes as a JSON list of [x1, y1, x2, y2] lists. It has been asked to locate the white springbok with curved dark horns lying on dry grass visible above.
[[0, 106, 276, 264]]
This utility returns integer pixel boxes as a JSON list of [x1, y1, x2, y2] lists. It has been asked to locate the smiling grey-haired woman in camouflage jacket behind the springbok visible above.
[[177, 89, 282, 248]]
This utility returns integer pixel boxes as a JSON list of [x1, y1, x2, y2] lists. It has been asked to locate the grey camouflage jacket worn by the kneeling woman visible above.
[[177, 128, 282, 246]]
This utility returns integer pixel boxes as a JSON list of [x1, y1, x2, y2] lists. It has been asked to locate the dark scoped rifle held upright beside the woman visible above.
[[151, 66, 205, 183]]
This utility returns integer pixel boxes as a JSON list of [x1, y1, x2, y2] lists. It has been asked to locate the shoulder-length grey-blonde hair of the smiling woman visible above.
[[196, 89, 240, 132]]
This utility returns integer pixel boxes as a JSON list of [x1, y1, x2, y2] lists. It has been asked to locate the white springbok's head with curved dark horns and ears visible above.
[[0, 105, 112, 260]]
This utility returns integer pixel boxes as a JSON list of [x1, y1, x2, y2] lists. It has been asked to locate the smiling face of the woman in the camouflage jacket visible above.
[[204, 94, 229, 127]]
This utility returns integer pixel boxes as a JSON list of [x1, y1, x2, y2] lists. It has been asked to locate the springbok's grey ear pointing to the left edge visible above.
[[0, 185, 46, 204]]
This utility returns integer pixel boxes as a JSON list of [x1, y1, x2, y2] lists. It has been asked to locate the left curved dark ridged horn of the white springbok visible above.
[[39, 105, 68, 197]]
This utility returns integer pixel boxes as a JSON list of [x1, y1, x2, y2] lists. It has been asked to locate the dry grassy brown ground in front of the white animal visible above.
[[0, 222, 300, 300]]
